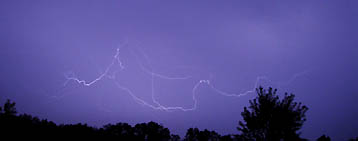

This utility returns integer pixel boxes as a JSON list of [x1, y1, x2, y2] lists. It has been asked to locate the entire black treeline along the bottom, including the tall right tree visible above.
[[0, 87, 358, 141]]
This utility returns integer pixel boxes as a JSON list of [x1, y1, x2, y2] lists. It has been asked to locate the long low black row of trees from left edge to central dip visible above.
[[0, 100, 180, 141]]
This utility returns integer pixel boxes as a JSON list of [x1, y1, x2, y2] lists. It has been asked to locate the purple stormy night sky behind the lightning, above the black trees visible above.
[[0, 0, 358, 140]]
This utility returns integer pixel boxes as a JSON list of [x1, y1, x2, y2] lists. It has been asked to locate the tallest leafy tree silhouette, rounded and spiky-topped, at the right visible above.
[[238, 87, 308, 141]]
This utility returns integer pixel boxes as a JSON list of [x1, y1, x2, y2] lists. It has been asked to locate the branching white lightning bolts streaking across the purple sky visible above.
[[64, 48, 306, 112]]
